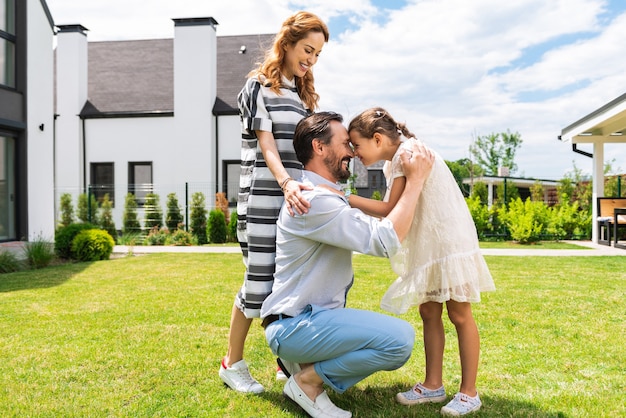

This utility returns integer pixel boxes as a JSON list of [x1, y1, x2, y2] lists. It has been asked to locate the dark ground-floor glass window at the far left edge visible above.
[[0, 135, 15, 240]]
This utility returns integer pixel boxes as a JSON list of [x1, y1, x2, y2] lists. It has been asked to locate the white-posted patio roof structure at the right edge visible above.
[[559, 93, 626, 243]]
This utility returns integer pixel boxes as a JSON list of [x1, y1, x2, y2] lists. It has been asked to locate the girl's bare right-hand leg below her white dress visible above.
[[447, 300, 480, 396]]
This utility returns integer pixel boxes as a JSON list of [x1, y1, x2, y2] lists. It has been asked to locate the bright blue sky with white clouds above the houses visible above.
[[46, 0, 626, 180]]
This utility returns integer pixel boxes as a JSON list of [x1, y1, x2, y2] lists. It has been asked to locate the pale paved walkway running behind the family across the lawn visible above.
[[0, 241, 626, 257]]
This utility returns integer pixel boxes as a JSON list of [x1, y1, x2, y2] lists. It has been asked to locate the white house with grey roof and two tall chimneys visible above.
[[55, 17, 274, 229]]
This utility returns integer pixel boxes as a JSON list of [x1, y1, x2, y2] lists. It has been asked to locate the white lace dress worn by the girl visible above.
[[381, 139, 495, 314]]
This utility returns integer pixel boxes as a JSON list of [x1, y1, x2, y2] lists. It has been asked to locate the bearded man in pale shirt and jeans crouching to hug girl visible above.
[[261, 112, 434, 417]]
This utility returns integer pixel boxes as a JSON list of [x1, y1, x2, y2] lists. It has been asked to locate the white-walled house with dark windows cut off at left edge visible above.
[[0, 0, 55, 242]]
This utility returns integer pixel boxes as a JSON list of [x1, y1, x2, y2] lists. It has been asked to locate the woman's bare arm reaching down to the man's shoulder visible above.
[[255, 131, 311, 216]]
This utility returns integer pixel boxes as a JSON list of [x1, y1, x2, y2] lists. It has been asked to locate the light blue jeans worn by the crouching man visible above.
[[265, 307, 415, 393]]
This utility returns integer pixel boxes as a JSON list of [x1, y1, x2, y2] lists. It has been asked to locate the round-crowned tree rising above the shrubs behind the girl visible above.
[[470, 129, 523, 176]]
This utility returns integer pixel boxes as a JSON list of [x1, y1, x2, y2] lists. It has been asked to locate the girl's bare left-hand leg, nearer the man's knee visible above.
[[419, 302, 446, 389]]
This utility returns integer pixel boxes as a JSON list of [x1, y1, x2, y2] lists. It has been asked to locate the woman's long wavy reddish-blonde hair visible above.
[[248, 12, 330, 111]]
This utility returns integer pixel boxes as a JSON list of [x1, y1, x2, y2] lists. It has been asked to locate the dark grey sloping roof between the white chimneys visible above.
[[81, 35, 274, 117]]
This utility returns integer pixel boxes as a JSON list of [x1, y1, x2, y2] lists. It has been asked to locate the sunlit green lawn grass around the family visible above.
[[0, 254, 626, 417]]
